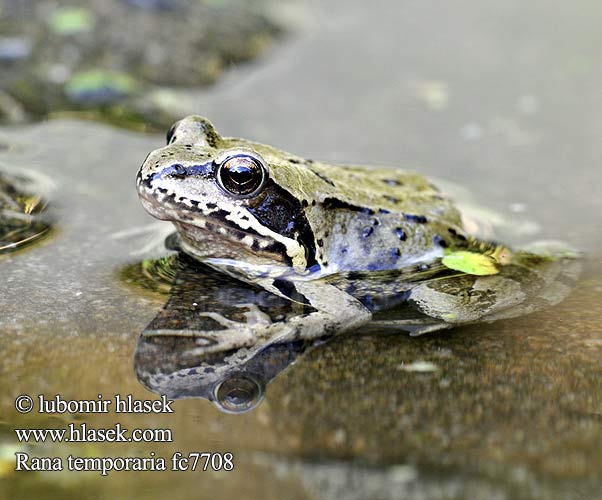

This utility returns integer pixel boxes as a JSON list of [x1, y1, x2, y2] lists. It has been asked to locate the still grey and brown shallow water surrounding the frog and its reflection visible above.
[[0, 0, 602, 499]]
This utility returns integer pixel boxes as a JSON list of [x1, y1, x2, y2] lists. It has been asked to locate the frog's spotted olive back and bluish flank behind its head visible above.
[[218, 138, 467, 273]]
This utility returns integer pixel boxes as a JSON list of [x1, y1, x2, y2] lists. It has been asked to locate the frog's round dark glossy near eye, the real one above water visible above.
[[216, 152, 268, 198]]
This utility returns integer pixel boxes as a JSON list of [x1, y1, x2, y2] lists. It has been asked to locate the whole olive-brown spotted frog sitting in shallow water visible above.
[[136, 115, 578, 353]]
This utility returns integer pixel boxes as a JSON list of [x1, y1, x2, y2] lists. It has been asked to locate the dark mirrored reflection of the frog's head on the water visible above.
[[133, 254, 326, 413]]
